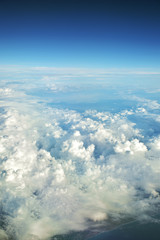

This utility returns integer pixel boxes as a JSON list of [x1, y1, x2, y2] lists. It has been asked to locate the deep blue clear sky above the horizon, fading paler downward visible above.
[[0, 0, 160, 69]]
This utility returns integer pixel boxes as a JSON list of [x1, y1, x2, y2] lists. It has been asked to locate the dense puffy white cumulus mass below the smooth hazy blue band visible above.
[[0, 102, 160, 240]]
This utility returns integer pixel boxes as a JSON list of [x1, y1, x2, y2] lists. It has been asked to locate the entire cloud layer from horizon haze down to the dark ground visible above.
[[0, 68, 160, 240]]
